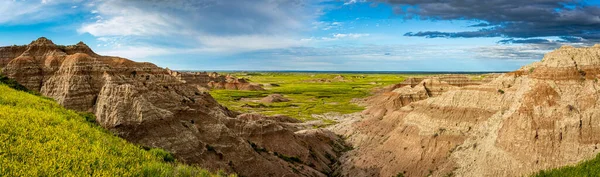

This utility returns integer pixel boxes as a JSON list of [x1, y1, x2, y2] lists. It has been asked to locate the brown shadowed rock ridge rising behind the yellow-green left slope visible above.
[[0, 38, 345, 176]]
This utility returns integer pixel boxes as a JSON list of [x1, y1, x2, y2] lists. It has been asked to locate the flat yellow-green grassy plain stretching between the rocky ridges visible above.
[[210, 72, 416, 120]]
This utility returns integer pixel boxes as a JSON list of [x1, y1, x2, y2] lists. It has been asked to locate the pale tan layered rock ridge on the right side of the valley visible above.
[[333, 45, 600, 176]]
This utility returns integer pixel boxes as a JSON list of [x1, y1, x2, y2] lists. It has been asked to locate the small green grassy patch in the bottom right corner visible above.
[[533, 154, 600, 177]]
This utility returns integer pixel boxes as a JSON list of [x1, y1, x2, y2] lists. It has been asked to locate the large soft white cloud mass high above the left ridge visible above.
[[78, 0, 324, 56]]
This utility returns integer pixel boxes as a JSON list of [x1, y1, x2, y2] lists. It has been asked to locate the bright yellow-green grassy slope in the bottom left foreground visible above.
[[0, 80, 225, 176]]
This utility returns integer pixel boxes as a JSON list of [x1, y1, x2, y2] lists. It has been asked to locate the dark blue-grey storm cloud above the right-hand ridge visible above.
[[370, 0, 600, 43]]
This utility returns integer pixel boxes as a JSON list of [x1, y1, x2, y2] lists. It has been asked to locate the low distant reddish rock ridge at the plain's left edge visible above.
[[168, 70, 264, 90]]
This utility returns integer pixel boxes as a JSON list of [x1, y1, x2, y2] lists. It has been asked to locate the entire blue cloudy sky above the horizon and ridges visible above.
[[0, 0, 600, 71]]
